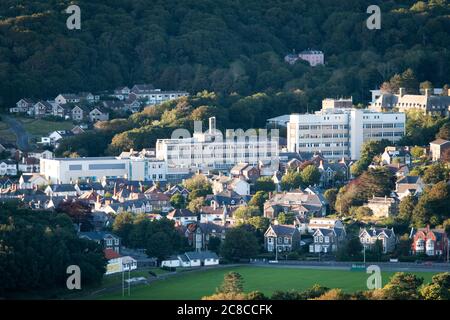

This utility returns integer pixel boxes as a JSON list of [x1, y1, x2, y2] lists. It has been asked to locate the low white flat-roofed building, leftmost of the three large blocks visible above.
[[40, 157, 167, 183]]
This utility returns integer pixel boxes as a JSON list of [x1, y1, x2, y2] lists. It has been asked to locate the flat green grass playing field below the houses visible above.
[[99, 266, 433, 300]]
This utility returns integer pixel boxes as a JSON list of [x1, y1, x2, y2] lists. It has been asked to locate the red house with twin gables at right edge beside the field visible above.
[[411, 226, 448, 256]]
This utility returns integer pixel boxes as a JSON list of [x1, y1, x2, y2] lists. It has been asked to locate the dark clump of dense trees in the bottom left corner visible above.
[[0, 203, 106, 298]]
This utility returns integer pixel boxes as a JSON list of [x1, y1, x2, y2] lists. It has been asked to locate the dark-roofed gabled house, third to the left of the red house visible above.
[[264, 224, 301, 252]]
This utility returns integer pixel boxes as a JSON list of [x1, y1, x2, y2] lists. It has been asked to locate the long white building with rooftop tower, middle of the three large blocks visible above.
[[156, 117, 278, 170]]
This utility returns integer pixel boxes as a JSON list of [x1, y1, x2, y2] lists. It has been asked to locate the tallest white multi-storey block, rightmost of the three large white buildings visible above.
[[287, 109, 405, 160]]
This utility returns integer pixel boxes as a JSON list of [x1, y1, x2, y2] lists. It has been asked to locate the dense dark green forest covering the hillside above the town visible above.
[[0, 0, 450, 112]]
